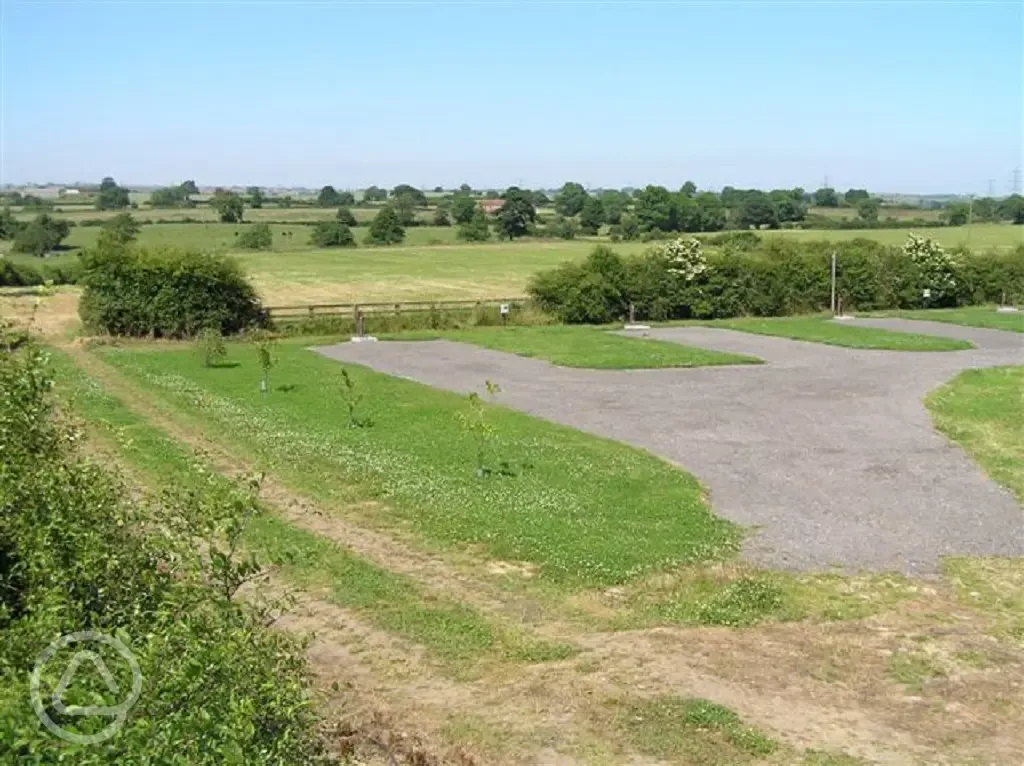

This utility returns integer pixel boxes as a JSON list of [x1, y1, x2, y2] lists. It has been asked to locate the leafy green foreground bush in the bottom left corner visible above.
[[0, 343, 323, 765]]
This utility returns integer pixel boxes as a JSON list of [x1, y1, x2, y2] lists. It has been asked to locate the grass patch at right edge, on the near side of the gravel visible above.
[[927, 367, 1024, 503]]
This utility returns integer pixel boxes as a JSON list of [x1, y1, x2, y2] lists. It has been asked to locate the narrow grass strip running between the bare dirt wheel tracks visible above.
[[51, 351, 573, 665]]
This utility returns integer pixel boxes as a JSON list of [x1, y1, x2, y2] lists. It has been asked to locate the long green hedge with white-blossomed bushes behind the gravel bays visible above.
[[528, 239, 1024, 324]]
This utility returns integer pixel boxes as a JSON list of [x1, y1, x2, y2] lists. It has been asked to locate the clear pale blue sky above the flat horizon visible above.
[[0, 0, 1024, 194]]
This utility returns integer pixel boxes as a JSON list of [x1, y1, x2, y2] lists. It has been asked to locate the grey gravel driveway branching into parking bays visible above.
[[316, 320, 1024, 573]]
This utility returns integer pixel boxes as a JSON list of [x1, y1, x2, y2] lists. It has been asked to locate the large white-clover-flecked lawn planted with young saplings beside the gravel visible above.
[[97, 342, 739, 589]]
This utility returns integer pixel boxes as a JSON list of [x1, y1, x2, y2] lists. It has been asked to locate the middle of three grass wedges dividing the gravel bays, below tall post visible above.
[[708, 316, 974, 351]]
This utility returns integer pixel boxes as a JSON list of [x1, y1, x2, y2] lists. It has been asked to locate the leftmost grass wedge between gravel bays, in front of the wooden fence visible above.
[[386, 325, 761, 370]]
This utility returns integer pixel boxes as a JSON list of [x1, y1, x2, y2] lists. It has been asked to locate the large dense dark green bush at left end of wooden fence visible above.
[[79, 247, 267, 338]]
